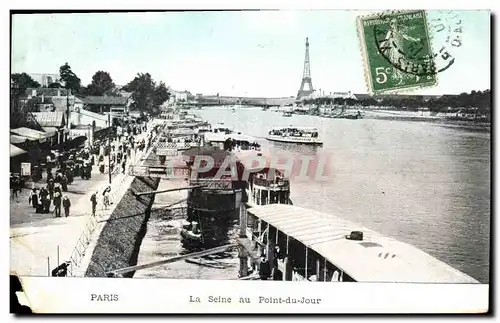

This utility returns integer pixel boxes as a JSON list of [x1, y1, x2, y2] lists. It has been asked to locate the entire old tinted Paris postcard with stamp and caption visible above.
[[9, 9, 492, 314]]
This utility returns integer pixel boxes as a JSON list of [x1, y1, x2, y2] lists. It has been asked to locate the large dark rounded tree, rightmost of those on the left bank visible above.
[[123, 73, 155, 112]]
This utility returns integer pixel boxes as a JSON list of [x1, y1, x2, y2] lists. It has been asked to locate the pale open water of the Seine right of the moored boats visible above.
[[193, 108, 491, 283]]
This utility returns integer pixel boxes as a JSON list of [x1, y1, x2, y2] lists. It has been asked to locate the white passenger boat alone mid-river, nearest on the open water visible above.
[[267, 126, 323, 145]]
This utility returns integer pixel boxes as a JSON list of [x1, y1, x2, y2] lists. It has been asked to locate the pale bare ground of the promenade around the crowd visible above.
[[10, 126, 152, 276]]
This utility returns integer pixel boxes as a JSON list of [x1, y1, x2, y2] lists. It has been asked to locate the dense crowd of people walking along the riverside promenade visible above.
[[10, 117, 158, 221]]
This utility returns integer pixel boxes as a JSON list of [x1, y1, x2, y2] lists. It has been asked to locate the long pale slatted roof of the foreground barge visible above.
[[248, 204, 479, 283]]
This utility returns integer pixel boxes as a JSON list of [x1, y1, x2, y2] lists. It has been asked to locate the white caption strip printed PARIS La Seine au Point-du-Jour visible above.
[[21, 277, 489, 314]]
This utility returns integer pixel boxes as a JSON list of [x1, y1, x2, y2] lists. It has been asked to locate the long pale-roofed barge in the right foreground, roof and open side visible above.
[[241, 204, 479, 284]]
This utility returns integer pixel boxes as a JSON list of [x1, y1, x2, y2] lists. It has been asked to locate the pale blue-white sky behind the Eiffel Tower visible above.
[[11, 10, 491, 97]]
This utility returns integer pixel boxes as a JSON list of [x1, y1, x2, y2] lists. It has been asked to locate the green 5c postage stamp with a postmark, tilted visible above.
[[357, 10, 437, 94]]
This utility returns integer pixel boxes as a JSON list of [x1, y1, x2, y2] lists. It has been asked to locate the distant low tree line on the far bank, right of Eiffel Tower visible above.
[[304, 90, 491, 114]]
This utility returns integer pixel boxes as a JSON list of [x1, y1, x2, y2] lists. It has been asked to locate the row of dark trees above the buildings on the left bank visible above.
[[11, 63, 170, 114]]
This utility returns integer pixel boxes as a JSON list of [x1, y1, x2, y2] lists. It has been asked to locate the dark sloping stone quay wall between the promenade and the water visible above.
[[85, 176, 160, 278]]
